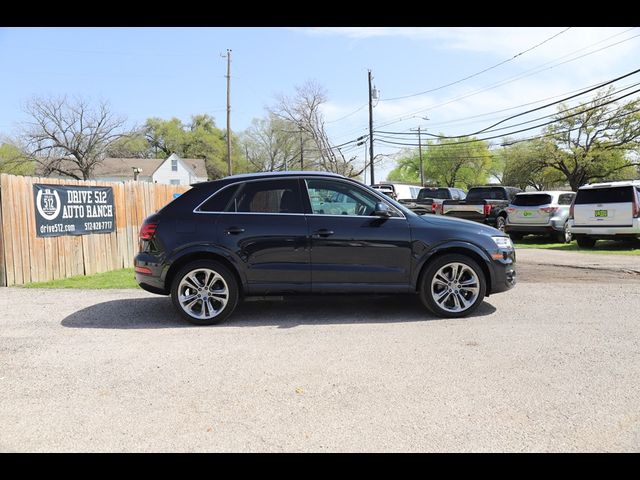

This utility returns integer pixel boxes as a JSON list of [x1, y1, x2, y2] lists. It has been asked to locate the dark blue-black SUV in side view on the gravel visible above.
[[135, 172, 516, 325]]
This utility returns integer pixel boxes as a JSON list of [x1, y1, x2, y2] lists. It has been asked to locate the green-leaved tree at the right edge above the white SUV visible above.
[[544, 88, 640, 190]]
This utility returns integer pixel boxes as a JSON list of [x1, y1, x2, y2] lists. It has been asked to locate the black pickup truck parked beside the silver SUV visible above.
[[442, 185, 522, 231]]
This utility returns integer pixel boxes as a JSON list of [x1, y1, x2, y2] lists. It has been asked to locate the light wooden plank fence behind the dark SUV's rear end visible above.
[[0, 174, 189, 286]]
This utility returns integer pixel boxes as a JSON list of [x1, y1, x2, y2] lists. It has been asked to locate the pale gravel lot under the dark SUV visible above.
[[0, 253, 640, 452]]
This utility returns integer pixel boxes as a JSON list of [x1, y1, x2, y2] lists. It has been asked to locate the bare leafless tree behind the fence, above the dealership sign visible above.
[[21, 96, 125, 180]]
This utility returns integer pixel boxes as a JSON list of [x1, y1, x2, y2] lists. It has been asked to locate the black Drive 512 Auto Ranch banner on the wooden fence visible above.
[[33, 183, 116, 237]]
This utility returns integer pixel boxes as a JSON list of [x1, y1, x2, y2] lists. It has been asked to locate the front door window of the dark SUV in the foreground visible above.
[[307, 179, 400, 216]]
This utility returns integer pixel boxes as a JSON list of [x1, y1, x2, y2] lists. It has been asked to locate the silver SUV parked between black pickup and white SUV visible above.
[[505, 191, 576, 243]]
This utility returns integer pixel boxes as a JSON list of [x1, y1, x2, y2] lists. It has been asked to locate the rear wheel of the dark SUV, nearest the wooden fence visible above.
[[171, 260, 240, 325]]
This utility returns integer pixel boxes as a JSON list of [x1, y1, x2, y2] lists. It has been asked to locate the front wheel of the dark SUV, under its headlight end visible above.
[[419, 253, 487, 318]]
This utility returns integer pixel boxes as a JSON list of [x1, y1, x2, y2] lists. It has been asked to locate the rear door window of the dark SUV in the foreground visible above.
[[227, 179, 304, 213]]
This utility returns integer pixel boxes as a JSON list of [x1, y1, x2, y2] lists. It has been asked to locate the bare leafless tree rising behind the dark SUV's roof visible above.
[[269, 81, 364, 177]]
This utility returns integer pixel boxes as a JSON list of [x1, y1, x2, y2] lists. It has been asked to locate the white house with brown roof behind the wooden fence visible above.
[[39, 153, 208, 185]]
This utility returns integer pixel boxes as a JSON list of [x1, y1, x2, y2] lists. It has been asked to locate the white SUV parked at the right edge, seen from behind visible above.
[[569, 180, 640, 248]]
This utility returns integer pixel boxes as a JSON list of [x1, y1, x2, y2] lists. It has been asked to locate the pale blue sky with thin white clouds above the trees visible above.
[[0, 27, 640, 179]]
